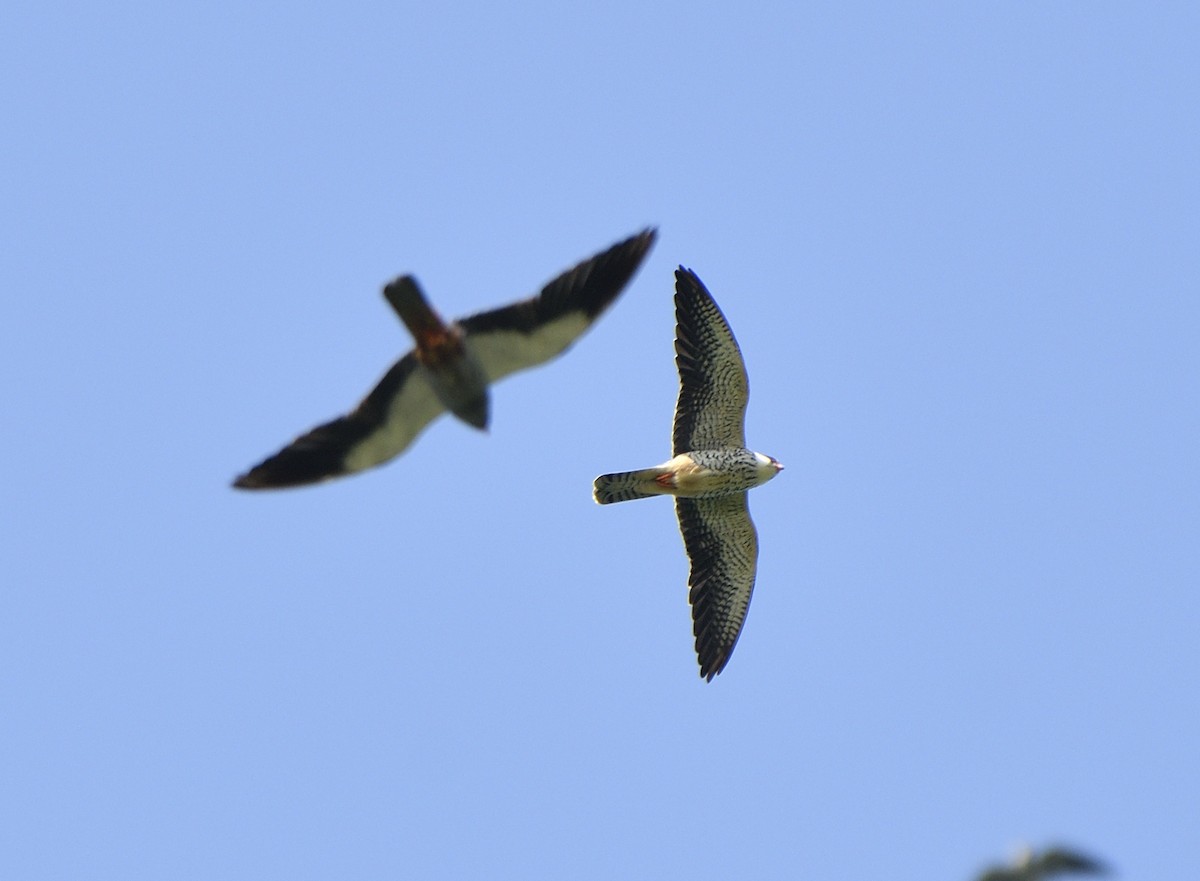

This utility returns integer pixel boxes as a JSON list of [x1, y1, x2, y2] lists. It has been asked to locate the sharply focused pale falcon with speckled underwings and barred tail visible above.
[[593, 266, 784, 682]]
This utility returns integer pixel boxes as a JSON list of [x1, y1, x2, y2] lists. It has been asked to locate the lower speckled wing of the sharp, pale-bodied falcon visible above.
[[676, 492, 758, 682]]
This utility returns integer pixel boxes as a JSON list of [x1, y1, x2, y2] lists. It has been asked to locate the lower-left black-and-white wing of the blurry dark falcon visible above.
[[233, 352, 443, 490]]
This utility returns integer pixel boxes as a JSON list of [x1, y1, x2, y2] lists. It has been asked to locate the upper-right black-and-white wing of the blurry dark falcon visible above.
[[458, 229, 656, 383]]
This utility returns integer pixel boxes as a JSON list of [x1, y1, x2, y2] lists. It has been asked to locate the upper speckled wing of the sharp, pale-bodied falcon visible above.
[[672, 266, 750, 463]]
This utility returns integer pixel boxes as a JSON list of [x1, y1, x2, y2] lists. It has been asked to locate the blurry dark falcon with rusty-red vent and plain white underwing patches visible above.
[[233, 229, 656, 490]]
